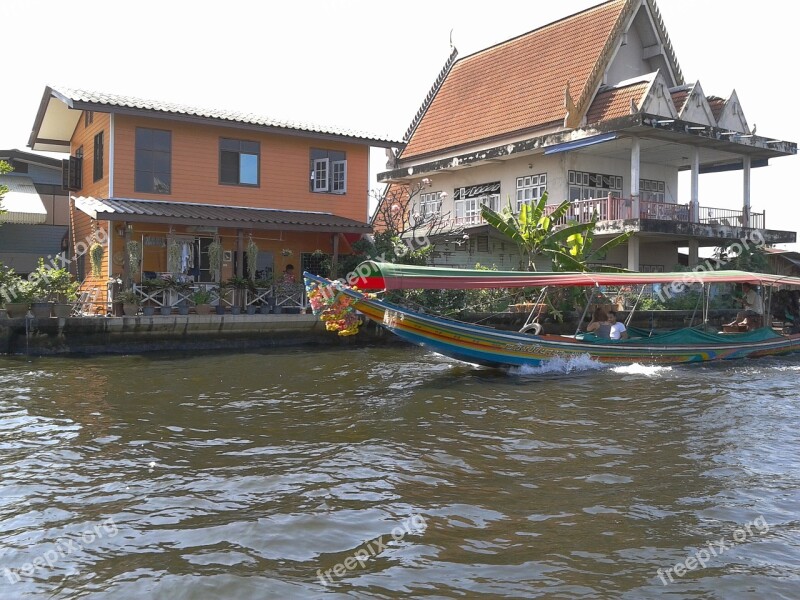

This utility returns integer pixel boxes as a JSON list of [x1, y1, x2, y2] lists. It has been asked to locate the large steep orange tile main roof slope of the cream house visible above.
[[402, 0, 626, 158]]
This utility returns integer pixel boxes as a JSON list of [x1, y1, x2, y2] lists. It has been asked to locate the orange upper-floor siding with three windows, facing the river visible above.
[[109, 115, 369, 222]]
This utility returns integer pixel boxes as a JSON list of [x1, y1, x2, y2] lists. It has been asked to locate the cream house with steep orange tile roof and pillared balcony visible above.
[[378, 0, 797, 271]]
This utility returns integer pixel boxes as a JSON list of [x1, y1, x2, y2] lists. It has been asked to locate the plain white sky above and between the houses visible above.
[[0, 0, 800, 247]]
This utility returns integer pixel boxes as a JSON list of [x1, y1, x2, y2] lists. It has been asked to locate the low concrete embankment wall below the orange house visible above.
[[0, 314, 396, 356]]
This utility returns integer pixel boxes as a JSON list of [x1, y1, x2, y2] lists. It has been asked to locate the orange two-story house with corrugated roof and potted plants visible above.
[[29, 87, 398, 304]]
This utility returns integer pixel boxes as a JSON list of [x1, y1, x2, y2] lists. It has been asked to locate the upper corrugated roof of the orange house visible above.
[[50, 86, 402, 145]]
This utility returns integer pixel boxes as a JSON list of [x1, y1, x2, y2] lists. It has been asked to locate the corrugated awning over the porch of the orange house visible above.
[[73, 196, 372, 233]]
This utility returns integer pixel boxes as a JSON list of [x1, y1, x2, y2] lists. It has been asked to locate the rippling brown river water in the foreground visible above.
[[0, 346, 800, 600]]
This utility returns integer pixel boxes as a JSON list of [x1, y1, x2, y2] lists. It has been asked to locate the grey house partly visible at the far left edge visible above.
[[0, 150, 69, 275]]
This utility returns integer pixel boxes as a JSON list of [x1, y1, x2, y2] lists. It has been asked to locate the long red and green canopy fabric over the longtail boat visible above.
[[354, 261, 800, 290]]
